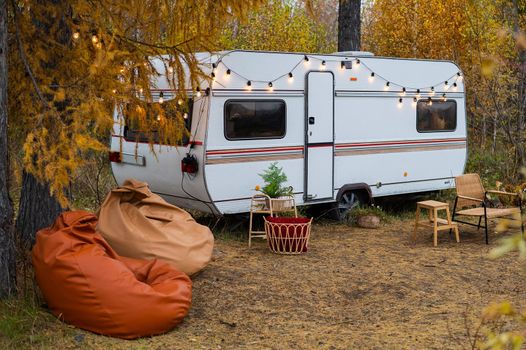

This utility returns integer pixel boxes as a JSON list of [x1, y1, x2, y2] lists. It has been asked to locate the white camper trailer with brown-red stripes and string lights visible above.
[[110, 51, 466, 214]]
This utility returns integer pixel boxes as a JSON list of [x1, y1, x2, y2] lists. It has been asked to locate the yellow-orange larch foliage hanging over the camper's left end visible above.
[[8, 0, 264, 205]]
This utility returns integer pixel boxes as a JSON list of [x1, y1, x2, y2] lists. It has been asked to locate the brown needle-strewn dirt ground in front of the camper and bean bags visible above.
[[1, 220, 526, 349]]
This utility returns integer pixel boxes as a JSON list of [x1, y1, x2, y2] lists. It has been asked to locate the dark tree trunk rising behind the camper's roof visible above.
[[338, 0, 361, 51]]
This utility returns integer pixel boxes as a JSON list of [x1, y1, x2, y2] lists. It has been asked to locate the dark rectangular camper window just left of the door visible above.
[[225, 100, 286, 140]]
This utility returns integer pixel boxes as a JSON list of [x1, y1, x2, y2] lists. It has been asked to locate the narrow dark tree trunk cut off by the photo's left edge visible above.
[[0, 0, 16, 298]]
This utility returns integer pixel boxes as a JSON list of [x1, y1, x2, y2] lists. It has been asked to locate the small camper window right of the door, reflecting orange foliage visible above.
[[416, 100, 457, 132]]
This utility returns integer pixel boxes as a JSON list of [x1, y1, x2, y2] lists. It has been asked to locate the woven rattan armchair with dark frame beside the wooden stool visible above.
[[452, 174, 524, 244]]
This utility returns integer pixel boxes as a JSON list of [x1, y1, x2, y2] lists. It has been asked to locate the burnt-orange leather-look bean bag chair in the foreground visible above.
[[32, 211, 192, 339]]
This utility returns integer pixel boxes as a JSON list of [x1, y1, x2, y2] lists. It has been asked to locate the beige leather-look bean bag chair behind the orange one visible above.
[[97, 179, 214, 275]]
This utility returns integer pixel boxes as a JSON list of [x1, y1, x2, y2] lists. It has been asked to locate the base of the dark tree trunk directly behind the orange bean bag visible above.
[[16, 172, 63, 249]]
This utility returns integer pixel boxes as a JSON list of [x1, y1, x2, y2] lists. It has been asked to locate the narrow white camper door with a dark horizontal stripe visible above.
[[304, 72, 334, 201]]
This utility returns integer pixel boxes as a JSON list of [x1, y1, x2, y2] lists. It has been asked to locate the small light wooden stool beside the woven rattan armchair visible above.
[[413, 200, 460, 247]]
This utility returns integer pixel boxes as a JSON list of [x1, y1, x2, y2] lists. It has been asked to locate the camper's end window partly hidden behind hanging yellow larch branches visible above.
[[124, 99, 193, 146]]
